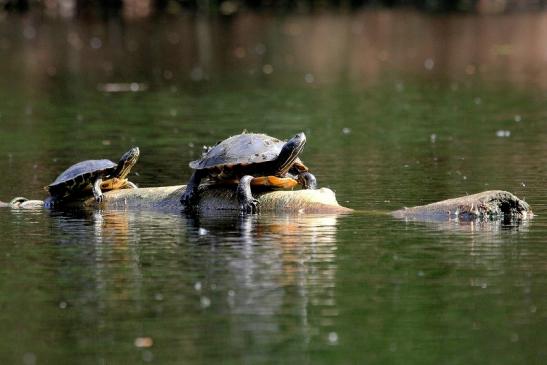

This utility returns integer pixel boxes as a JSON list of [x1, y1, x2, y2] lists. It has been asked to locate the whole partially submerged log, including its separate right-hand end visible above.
[[0, 185, 533, 221]]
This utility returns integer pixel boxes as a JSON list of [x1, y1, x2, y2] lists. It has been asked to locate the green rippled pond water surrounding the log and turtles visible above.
[[0, 11, 547, 364]]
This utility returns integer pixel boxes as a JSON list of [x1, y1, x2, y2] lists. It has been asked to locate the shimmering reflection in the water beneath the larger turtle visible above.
[[182, 214, 338, 352]]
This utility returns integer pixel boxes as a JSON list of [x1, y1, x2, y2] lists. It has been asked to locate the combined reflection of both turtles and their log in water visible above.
[[48, 203, 338, 352]]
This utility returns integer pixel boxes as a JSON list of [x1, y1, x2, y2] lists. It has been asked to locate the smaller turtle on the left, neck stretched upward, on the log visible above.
[[45, 147, 140, 208]]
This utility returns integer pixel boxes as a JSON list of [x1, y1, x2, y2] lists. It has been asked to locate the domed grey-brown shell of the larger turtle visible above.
[[189, 133, 285, 170]]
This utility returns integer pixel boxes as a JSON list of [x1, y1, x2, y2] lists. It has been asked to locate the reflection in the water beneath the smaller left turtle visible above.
[[46, 209, 146, 308]]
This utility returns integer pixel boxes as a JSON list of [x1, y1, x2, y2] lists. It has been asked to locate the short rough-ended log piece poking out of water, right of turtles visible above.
[[391, 190, 533, 220]]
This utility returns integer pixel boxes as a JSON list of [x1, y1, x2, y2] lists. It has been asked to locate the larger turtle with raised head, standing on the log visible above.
[[180, 133, 317, 213]]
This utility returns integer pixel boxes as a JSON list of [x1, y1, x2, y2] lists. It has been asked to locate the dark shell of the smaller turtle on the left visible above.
[[47, 160, 117, 195]]
